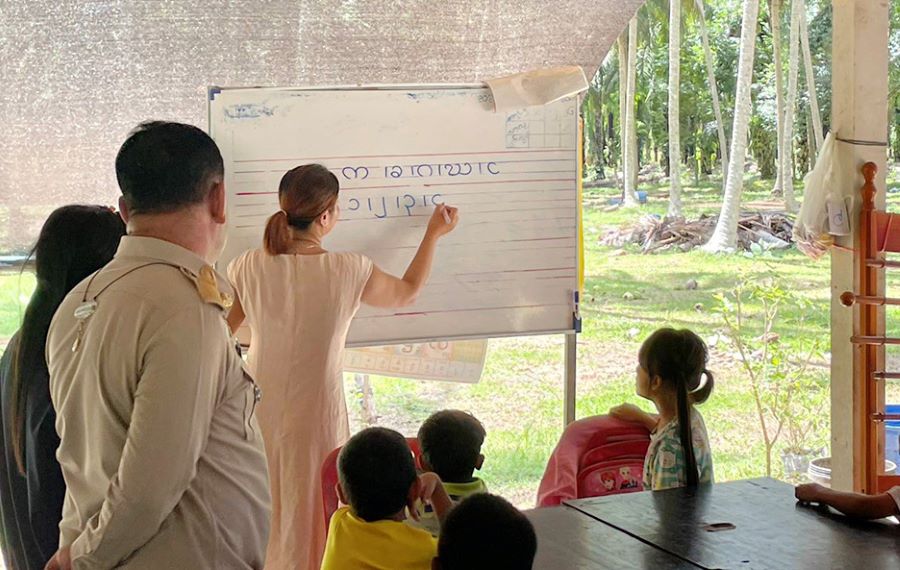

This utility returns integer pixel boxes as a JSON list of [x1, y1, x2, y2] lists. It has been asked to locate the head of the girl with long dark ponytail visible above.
[[637, 328, 713, 486]]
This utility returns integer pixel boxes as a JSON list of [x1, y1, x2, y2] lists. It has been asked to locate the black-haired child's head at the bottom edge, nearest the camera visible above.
[[433, 493, 537, 570]]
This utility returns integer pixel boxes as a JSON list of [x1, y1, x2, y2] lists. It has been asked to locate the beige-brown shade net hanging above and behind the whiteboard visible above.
[[0, 0, 643, 254]]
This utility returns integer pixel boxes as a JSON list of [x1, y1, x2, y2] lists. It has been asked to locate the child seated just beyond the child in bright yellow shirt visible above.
[[410, 410, 487, 536]]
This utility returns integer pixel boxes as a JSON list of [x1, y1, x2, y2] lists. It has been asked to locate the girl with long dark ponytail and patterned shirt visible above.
[[610, 328, 713, 491]]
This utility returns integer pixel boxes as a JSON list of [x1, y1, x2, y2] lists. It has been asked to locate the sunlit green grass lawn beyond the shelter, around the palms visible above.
[[0, 169, 900, 506]]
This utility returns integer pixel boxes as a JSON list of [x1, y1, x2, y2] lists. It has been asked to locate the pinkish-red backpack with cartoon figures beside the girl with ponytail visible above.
[[538, 416, 650, 507]]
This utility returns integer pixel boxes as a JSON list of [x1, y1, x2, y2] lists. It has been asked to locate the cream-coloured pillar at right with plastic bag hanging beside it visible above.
[[831, 0, 890, 491]]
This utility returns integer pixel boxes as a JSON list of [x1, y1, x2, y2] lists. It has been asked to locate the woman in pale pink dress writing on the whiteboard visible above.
[[228, 164, 458, 570]]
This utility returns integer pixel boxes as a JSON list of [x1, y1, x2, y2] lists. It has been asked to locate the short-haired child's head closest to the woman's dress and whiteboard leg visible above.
[[419, 410, 485, 483]]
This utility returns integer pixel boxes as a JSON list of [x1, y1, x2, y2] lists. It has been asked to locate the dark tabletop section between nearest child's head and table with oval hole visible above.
[[525, 506, 698, 570]]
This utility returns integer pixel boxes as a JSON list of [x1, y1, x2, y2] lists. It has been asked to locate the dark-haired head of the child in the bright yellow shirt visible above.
[[338, 427, 416, 522]]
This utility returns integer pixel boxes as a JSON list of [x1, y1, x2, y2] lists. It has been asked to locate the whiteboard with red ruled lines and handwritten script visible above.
[[209, 86, 580, 346]]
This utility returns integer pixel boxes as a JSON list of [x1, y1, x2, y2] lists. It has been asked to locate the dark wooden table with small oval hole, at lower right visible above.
[[566, 479, 900, 570]]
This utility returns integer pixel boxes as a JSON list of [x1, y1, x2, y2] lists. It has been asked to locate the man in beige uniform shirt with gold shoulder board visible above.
[[47, 123, 270, 570]]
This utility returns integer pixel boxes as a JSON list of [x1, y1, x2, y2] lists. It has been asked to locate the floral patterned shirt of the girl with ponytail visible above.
[[644, 409, 713, 491]]
